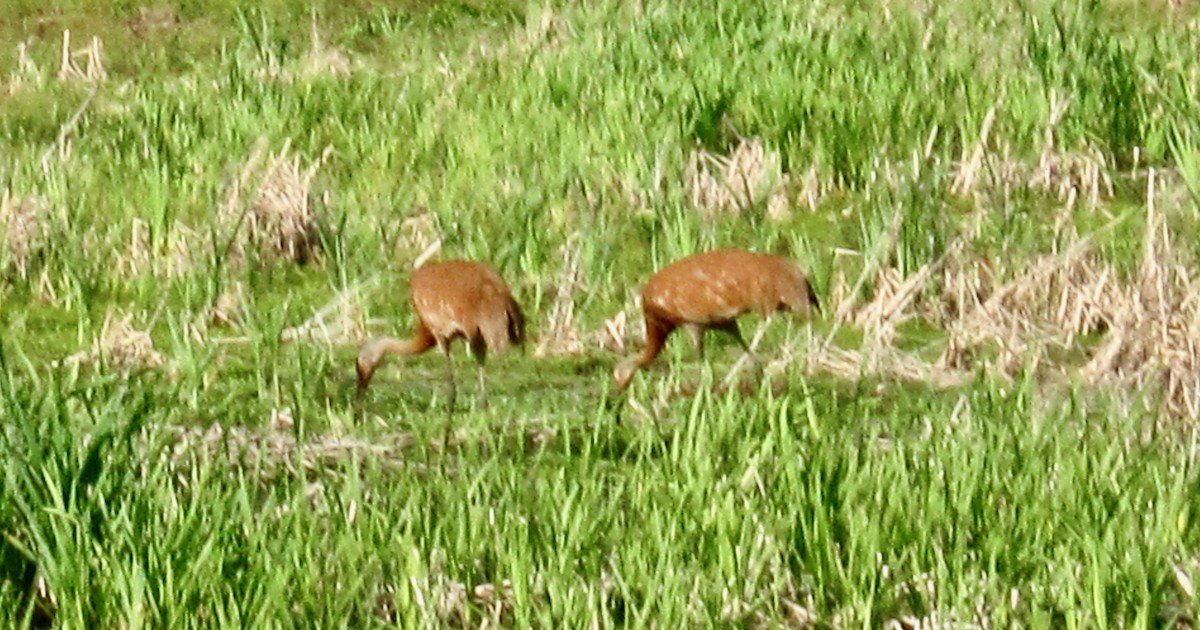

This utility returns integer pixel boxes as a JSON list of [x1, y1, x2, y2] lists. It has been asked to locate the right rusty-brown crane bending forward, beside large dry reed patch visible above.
[[612, 250, 821, 391]]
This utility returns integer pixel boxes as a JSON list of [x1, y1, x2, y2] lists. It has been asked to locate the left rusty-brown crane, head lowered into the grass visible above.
[[356, 260, 524, 410]]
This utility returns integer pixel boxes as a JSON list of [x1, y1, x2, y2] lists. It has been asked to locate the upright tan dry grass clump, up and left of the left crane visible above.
[[218, 138, 332, 264]]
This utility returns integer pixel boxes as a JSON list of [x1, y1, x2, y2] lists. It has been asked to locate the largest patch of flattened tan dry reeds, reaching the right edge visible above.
[[840, 162, 1200, 419]]
